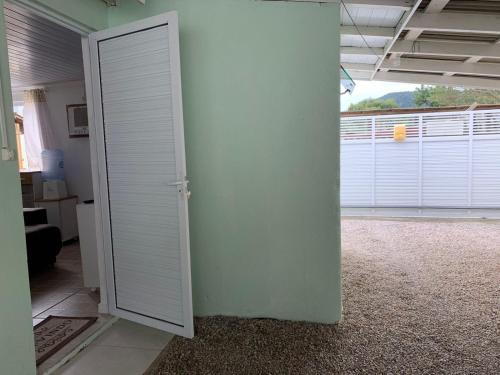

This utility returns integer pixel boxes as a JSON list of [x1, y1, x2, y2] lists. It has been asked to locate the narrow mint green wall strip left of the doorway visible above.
[[0, 0, 35, 375]]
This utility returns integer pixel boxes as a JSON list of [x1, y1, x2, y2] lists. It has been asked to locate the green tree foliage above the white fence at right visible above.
[[415, 85, 500, 107]]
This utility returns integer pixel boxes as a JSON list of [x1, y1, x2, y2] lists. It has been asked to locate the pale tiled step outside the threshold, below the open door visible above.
[[55, 320, 172, 375]]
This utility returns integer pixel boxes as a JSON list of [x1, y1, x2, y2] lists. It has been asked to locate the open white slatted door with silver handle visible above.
[[89, 12, 193, 337]]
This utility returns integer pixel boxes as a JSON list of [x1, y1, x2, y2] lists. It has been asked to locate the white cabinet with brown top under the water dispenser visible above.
[[35, 195, 78, 241]]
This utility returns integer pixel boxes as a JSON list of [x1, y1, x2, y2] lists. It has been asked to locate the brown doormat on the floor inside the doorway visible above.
[[33, 315, 97, 366]]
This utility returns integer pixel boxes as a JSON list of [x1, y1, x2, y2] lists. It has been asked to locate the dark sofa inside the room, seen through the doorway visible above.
[[23, 208, 62, 271]]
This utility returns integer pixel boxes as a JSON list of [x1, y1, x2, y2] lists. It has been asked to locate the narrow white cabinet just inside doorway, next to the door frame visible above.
[[76, 203, 99, 288]]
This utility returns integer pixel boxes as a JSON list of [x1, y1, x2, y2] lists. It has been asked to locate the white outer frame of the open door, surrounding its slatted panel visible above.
[[82, 11, 194, 337]]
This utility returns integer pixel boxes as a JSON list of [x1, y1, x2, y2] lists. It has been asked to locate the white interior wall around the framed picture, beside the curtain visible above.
[[46, 82, 93, 201]]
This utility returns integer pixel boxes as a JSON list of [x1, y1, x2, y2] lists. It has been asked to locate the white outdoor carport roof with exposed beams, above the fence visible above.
[[340, 0, 500, 89]]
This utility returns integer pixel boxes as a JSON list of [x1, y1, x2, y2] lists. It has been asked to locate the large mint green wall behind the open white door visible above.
[[108, 0, 341, 322]]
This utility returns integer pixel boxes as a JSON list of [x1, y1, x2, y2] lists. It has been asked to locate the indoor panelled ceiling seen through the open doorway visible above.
[[4, 2, 83, 88]]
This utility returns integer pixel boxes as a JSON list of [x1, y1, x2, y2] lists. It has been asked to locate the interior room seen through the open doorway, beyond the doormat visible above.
[[4, 3, 99, 368]]
